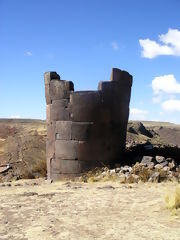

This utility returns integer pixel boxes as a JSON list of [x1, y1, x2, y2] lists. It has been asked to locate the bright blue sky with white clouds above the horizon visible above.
[[0, 0, 180, 123]]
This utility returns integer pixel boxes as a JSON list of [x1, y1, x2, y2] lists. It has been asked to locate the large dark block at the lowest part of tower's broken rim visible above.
[[70, 91, 101, 122]]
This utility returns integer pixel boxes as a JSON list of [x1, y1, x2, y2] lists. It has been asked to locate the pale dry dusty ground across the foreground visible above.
[[0, 180, 180, 240]]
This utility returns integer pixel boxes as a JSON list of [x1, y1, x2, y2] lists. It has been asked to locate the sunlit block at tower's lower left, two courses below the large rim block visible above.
[[55, 140, 79, 160]]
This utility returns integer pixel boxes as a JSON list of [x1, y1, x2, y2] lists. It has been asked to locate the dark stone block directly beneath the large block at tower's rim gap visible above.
[[71, 122, 93, 141]]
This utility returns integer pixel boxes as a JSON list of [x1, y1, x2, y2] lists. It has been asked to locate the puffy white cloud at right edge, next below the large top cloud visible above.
[[152, 74, 180, 94]]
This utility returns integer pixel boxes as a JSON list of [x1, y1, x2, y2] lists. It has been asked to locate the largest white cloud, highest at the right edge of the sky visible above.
[[139, 28, 180, 58]]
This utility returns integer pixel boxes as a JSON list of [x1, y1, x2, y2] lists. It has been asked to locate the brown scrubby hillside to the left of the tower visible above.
[[0, 119, 46, 181]]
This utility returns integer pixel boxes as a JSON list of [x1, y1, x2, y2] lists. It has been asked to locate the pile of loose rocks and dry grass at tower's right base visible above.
[[80, 156, 180, 183]]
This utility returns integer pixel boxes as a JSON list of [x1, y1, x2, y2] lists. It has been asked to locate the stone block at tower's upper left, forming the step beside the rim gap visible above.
[[49, 80, 74, 101]]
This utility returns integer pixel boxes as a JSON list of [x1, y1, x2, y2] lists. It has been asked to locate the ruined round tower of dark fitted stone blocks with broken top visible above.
[[44, 68, 132, 180]]
